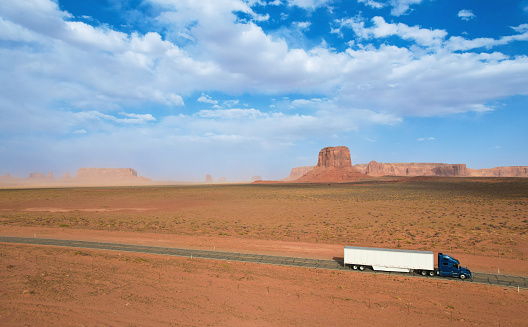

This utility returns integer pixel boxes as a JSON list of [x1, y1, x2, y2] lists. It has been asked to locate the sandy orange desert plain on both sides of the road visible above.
[[0, 178, 528, 326]]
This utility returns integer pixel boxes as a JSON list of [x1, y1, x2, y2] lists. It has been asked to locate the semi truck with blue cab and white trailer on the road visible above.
[[344, 246, 472, 279]]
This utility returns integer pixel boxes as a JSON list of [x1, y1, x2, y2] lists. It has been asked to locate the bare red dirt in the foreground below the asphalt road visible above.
[[0, 238, 528, 326]]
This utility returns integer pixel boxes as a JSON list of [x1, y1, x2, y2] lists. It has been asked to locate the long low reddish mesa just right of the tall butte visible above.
[[354, 161, 468, 177]]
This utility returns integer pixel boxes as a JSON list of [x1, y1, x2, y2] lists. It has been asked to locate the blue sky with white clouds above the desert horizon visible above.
[[0, 0, 528, 181]]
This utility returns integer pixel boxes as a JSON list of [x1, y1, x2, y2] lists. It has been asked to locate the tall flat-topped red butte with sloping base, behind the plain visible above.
[[295, 146, 366, 183]]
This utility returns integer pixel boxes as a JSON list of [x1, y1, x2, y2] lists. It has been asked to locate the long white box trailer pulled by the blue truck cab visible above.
[[344, 246, 434, 275]]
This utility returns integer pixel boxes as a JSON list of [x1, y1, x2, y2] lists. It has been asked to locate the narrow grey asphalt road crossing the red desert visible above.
[[0, 236, 528, 289]]
